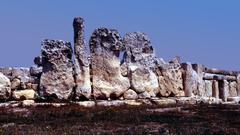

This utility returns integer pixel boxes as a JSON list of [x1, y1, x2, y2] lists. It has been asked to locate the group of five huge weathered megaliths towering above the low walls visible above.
[[35, 17, 184, 100]]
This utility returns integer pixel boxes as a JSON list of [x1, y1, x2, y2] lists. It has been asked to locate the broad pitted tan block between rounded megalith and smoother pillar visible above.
[[158, 61, 184, 97]]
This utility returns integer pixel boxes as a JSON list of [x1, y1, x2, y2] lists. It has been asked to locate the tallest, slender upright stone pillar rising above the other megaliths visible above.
[[73, 17, 92, 99]]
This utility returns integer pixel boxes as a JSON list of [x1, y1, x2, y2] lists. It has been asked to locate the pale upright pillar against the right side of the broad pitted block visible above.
[[182, 63, 199, 97]]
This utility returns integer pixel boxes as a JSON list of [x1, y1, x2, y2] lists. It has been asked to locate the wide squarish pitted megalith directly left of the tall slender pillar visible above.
[[40, 39, 75, 100]]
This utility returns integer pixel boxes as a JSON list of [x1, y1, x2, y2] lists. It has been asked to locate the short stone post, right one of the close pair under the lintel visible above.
[[219, 80, 229, 102]]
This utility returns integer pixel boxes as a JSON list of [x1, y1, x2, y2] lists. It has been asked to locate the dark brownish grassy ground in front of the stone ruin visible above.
[[0, 105, 240, 135]]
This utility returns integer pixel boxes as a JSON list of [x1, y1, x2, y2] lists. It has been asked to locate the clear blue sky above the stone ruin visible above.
[[0, 0, 240, 70]]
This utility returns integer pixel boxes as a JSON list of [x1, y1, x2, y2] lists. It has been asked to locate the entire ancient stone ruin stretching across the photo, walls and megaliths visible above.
[[0, 17, 240, 106]]
